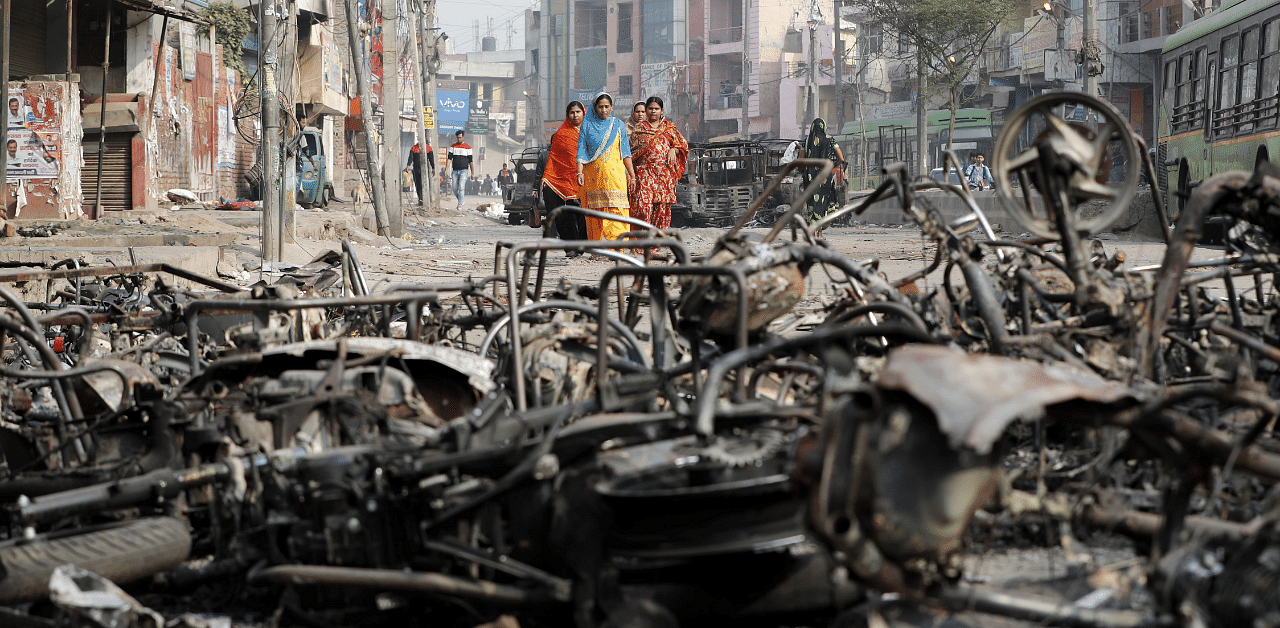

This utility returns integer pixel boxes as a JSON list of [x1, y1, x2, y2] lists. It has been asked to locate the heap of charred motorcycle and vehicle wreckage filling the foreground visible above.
[[0, 95, 1280, 628]]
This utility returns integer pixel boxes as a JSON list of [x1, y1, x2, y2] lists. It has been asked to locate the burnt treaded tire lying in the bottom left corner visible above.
[[0, 517, 191, 604]]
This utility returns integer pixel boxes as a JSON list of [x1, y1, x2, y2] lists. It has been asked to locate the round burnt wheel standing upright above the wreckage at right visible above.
[[991, 92, 1142, 239]]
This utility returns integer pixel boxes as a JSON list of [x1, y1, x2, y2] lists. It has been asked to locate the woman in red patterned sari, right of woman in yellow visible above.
[[631, 96, 689, 229]]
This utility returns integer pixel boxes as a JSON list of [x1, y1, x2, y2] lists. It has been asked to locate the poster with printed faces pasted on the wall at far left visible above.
[[5, 90, 63, 179]]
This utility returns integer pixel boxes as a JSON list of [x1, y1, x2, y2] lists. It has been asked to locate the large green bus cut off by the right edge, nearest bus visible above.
[[1156, 0, 1280, 217]]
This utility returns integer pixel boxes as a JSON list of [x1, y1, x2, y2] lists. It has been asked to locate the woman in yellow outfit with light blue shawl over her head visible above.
[[577, 93, 636, 240]]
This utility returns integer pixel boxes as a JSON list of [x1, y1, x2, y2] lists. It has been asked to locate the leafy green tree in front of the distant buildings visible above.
[[852, 0, 1019, 174]]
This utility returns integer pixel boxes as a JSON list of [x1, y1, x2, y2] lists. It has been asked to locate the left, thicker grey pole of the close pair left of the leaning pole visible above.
[[257, 0, 282, 262]]
